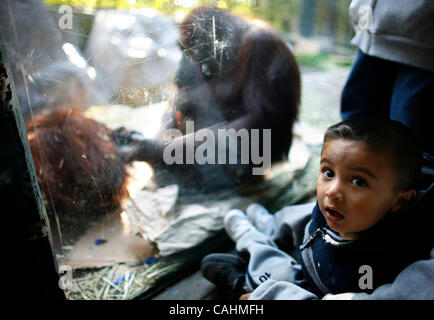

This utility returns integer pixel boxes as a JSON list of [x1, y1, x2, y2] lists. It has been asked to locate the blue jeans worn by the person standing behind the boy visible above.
[[341, 50, 434, 155]]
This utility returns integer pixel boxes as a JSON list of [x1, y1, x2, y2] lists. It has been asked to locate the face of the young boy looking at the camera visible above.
[[317, 138, 401, 240]]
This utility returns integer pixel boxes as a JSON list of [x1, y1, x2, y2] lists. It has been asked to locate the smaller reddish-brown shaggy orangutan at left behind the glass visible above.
[[27, 109, 127, 218]]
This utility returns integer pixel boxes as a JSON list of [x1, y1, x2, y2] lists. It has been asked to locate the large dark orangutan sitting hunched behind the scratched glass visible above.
[[113, 7, 301, 189]]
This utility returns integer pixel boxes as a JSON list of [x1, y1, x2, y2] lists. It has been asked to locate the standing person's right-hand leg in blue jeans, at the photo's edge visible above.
[[390, 65, 434, 155]]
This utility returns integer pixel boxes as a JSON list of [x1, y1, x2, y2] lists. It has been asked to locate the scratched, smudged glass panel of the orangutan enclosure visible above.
[[0, 0, 354, 299]]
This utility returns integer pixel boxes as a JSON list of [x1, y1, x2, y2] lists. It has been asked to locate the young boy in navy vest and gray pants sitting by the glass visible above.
[[202, 118, 433, 299]]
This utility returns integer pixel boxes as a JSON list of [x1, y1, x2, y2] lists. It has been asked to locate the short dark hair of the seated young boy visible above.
[[324, 117, 421, 191]]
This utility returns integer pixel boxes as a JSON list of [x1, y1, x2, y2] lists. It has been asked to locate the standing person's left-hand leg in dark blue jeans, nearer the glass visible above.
[[341, 50, 397, 120]]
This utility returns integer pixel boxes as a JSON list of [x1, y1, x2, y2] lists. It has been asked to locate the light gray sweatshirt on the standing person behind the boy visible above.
[[349, 0, 434, 71]]
